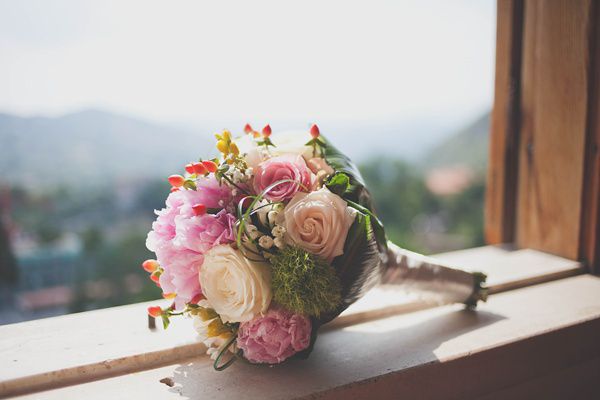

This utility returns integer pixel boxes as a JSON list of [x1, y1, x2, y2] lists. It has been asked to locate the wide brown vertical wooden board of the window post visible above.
[[516, 0, 592, 259]]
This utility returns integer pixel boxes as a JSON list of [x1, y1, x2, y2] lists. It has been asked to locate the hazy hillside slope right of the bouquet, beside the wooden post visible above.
[[423, 112, 490, 174]]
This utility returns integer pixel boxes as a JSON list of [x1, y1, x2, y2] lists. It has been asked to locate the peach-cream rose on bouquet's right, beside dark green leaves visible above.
[[282, 188, 355, 262]]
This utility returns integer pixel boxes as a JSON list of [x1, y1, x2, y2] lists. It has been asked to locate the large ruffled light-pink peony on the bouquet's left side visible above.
[[146, 176, 236, 308]]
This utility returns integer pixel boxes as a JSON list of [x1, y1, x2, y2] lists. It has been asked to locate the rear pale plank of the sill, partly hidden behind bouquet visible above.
[[0, 246, 580, 396]]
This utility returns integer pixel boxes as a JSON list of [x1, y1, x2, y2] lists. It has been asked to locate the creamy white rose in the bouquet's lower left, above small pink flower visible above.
[[199, 245, 271, 322]]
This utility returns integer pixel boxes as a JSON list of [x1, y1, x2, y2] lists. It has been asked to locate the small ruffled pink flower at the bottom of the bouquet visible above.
[[237, 304, 311, 364]]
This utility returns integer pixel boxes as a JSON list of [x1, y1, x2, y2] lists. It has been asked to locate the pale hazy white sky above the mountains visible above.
[[0, 0, 496, 125]]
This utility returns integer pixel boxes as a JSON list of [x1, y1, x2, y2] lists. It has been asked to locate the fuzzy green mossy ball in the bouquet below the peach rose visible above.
[[269, 246, 342, 317]]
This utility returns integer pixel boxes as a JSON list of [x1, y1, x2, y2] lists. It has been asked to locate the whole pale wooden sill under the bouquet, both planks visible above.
[[0, 246, 600, 399]]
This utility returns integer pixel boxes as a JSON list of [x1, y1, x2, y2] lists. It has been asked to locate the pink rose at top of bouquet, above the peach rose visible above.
[[254, 154, 316, 201]]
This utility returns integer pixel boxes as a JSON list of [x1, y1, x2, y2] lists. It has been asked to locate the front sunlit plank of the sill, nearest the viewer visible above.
[[14, 275, 600, 399]]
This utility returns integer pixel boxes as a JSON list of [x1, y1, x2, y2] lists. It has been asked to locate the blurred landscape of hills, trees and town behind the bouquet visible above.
[[0, 111, 489, 324]]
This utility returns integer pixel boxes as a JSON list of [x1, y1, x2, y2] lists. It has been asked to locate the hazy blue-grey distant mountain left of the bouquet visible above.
[[0, 110, 212, 188]]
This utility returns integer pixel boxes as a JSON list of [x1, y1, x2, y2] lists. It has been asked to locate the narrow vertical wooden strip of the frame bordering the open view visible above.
[[485, 0, 523, 244]]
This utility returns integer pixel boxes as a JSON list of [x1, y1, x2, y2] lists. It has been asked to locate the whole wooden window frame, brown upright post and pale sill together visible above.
[[0, 0, 600, 400]]
